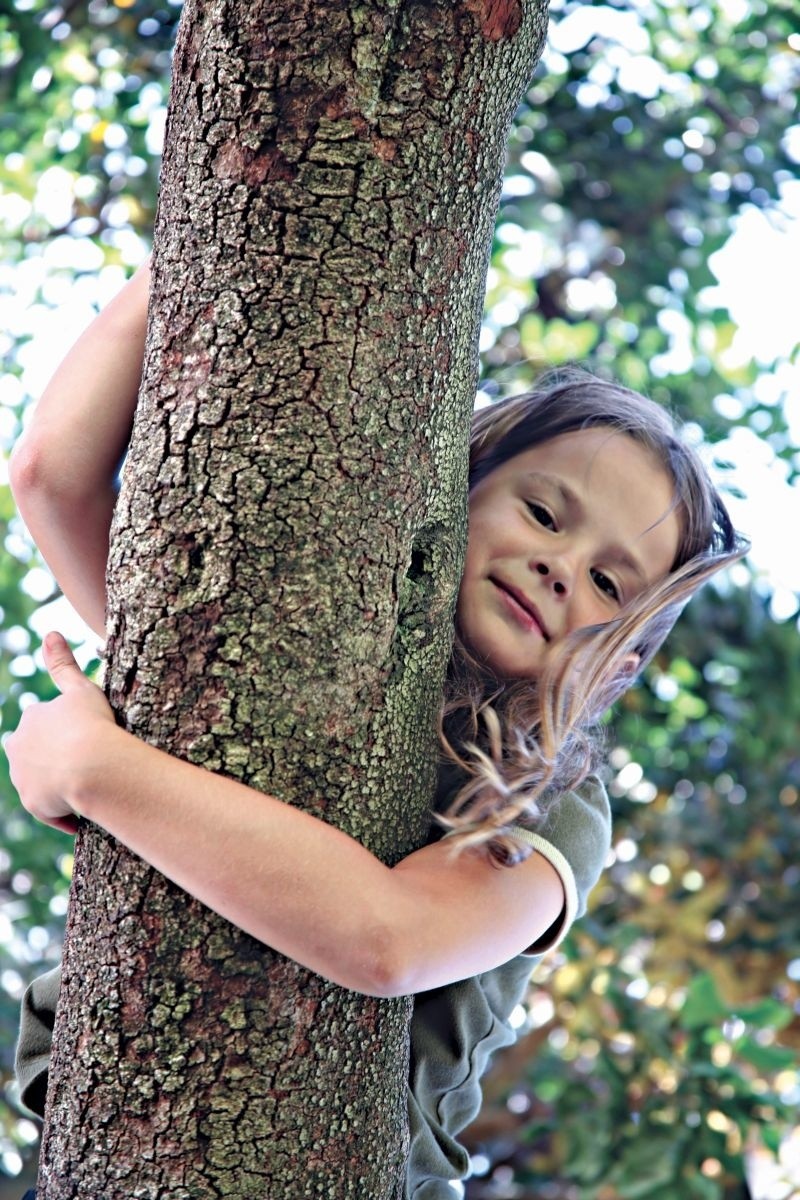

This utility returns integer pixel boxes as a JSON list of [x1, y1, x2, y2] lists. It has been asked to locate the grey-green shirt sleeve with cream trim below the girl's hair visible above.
[[509, 775, 612, 954]]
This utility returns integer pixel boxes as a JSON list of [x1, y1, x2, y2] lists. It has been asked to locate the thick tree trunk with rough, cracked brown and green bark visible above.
[[40, 0, 546, 1200]]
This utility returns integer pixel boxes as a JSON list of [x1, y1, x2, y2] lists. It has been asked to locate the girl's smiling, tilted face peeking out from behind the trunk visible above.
[[457, 427, 681, 679]]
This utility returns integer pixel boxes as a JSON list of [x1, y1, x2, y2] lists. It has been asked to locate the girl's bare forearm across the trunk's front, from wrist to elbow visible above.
[[67, 728, 403, 995]]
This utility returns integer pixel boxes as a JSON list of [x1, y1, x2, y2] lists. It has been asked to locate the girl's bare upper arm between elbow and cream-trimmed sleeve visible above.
[[385, 839, 569, 996]]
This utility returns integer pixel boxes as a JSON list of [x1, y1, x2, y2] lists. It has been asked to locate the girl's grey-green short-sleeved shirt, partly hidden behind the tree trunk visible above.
[[17, 776, 610, 1200]]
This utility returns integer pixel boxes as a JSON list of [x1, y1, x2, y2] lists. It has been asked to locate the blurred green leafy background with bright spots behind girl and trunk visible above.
[[0, 0, 800, 1200]]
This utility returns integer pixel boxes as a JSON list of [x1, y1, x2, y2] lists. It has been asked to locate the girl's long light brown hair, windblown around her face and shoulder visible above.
[[438, 367, 748, 865]]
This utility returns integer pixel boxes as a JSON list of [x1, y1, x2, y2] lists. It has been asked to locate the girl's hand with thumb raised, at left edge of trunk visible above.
[[5, 634, 116, 833]]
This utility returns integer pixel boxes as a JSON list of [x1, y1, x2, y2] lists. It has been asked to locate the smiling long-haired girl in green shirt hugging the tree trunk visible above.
[[6, 258, 745, 1200]]
